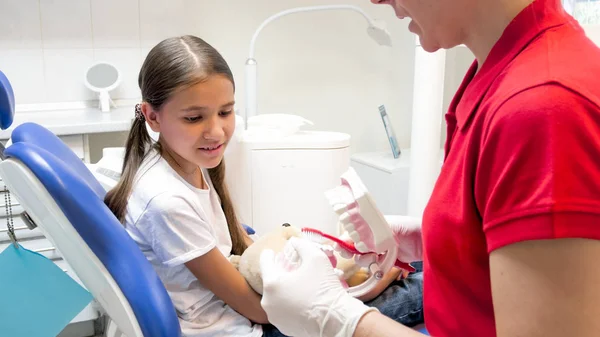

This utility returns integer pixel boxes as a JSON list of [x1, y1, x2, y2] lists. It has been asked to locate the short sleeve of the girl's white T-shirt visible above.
[[135, 193, 217, 267]]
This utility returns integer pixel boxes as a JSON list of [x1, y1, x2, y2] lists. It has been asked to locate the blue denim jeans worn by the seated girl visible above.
[[263, 262, 424, 337]]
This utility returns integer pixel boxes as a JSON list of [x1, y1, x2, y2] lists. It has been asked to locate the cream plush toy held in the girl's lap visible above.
[[229, 224, 369, 295]]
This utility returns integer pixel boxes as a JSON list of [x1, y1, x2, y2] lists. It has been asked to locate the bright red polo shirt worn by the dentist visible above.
[[423, 0, 600, 337]]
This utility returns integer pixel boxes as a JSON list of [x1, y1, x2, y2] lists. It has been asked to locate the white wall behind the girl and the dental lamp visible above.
[[0, 0, 472, 152]]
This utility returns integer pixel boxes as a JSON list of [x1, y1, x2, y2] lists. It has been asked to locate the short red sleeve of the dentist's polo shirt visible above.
[[473, 84, 600, 252]]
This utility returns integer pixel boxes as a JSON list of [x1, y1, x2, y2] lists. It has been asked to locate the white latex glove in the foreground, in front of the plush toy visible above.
[[260, 237, 377, 337]]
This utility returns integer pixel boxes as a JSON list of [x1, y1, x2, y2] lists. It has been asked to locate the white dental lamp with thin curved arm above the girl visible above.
[[244, 5, 392, 129]]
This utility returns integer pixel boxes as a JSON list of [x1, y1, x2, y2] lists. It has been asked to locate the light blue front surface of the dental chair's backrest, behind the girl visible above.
[[10, 123, 106, 199]]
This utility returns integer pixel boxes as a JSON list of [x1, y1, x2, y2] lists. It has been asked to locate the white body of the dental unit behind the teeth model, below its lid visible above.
[[251, 148, 350, 235]]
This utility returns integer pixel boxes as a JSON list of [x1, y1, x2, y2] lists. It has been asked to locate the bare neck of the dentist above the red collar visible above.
[[465, 0, 534, 67]]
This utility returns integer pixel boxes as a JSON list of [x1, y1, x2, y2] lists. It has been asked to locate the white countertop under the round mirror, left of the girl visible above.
[[0, 107, 134, 139]]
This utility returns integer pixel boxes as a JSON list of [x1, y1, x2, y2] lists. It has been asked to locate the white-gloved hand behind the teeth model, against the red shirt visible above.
[[385, 215, 423, 263]]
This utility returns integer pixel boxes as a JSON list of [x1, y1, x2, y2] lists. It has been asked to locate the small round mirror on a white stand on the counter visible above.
[[85, 62, 121, 111]]
